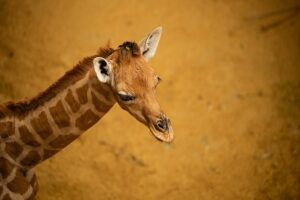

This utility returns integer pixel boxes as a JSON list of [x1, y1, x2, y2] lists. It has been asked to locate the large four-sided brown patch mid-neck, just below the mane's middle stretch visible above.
[[49, 101, 70, 128]]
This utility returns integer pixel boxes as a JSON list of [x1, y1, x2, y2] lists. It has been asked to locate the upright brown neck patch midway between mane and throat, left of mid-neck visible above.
[[31, 111, 52, 139]]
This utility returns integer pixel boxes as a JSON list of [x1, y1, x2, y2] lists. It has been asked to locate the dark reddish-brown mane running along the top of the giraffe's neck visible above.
[[0, 45, 114, 119]]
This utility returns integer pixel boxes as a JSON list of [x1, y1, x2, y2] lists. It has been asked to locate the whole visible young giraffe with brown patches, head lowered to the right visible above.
[[0, 27, 173, 200]]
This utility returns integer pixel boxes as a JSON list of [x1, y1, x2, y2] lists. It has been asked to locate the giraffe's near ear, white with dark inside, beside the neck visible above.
[[93, 57, 112, 83]]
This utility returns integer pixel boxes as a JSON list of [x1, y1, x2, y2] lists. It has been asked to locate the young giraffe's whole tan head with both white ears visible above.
[[93, 27, 173, 142]]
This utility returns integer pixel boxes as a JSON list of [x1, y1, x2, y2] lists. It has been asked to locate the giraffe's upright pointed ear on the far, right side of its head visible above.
[[139, 26, 162, 61]]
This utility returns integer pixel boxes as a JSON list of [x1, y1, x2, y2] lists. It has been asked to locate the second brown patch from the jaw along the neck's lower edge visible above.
[[75, 110, 100, 131]]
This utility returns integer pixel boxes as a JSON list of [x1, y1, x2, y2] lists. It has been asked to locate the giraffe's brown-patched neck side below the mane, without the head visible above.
[[2, 68, 116, 169]]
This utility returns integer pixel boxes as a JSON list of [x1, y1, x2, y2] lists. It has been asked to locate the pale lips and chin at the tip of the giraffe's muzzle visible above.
[[149, 123, 174, 143]]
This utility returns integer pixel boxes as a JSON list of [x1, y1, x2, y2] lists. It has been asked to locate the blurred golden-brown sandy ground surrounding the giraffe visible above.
[[0, 0, 300, 200]]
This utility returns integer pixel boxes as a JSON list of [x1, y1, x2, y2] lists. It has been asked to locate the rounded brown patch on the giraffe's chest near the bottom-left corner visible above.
[[7, 171, 29, 194]]
